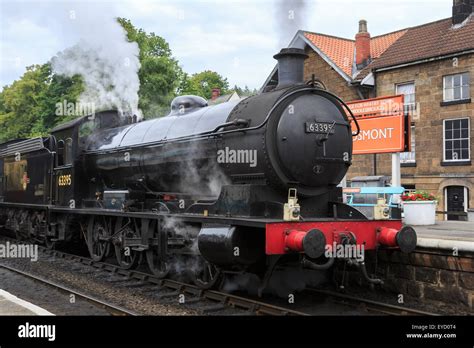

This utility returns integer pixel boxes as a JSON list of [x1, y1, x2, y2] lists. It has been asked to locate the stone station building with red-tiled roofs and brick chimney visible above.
[[264, 0, 474, 220]]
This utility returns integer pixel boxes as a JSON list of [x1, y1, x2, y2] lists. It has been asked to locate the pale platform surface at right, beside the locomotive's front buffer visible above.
[[413, 221, 474, 252]]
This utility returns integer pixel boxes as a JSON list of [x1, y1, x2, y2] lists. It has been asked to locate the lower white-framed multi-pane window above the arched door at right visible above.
[[443, 118, 470, 162]]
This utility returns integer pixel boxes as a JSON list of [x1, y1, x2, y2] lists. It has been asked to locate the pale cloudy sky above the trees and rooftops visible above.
[[0, 0, 452, 88]]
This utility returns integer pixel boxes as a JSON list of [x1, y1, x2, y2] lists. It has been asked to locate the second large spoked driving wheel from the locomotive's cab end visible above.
[[113, 218, 141, 269]]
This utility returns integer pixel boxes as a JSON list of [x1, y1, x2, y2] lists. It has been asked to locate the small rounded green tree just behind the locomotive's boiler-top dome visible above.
[[180, 70, 229, 99]]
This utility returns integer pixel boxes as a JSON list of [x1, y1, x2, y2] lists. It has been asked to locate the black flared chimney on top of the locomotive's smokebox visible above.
[[273, 48, 308, 88]]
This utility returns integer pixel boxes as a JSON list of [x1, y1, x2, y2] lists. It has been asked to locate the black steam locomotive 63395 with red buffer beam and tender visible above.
[[0, 48, 416, 288]]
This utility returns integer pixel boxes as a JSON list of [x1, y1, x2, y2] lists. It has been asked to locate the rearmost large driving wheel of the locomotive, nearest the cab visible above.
[[87, 217, 110, 262]]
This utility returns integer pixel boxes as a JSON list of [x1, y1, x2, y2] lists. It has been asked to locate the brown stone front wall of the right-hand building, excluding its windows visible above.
[[376, 54, 474, 210]]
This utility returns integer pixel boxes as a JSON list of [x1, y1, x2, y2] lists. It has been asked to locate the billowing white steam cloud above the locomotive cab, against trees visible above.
[[51, 3, 141, 117]]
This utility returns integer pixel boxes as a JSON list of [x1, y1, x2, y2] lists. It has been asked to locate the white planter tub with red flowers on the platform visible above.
[[401, 191, 438, 225]]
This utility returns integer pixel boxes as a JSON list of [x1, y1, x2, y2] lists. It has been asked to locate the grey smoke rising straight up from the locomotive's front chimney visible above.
[[274, 0, 309, 48]]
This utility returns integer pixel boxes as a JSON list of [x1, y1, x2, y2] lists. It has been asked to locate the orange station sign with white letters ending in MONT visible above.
[[347, 95, 410, 155]]
